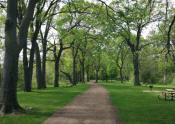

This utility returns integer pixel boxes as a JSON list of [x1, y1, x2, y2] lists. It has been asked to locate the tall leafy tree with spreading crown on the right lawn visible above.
[[100, 0, 162, 85]]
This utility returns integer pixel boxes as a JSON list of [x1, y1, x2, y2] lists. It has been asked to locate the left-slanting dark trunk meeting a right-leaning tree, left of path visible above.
[[35, 43, 43, 89]]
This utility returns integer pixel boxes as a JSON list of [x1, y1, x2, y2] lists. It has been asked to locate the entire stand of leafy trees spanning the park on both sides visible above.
[[0, 0, 175, 114]]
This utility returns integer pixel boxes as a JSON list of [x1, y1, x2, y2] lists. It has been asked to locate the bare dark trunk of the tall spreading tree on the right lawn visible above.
[[133, 52, 140, 86]]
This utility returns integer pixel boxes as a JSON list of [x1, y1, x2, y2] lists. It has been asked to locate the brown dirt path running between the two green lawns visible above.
[[43, 82, 120, 124]]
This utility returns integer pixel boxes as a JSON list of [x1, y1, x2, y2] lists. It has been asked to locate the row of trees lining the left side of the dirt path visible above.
[[0, 0, 109, 114]]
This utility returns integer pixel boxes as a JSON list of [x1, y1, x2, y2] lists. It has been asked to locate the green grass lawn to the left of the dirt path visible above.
[[0, 84, 89, 124]]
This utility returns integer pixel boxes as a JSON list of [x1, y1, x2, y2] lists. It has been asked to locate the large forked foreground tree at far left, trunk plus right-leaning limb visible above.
[[0, 0, 37, 114]]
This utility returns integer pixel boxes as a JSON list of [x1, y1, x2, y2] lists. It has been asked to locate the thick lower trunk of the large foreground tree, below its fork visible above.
[[0, 48, 22, 114]]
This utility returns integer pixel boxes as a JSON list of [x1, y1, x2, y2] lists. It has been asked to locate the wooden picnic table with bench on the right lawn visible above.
[[162, 89, 175, 100]]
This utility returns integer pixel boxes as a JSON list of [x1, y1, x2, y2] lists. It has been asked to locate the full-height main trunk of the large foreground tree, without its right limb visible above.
[[0, 0, 22, 115]]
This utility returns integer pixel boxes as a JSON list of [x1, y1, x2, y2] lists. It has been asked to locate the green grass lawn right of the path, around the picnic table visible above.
[[100, 81, 175, 124]]
